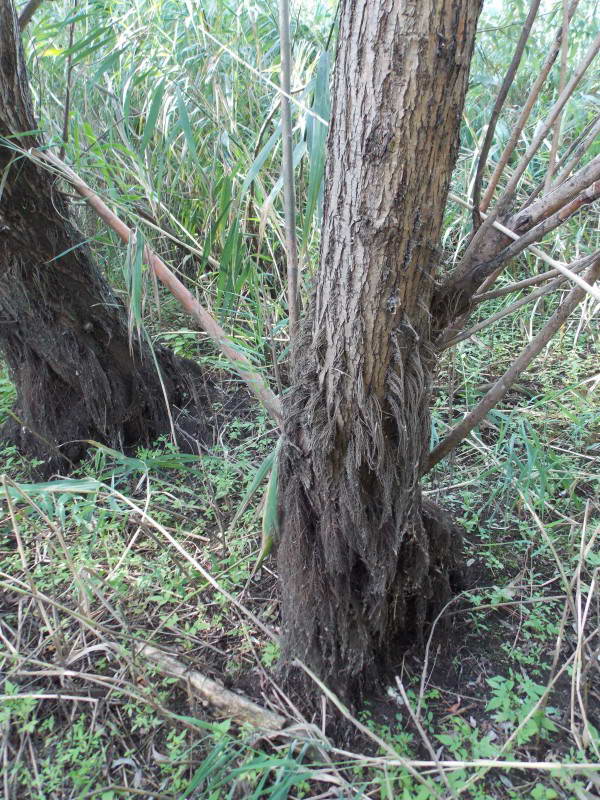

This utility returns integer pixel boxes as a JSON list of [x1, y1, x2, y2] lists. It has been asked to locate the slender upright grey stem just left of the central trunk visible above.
[[279, 0, 298, 342]]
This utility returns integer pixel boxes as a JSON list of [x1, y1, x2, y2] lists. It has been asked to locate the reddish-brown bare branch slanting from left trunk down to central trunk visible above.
[[31, 150, 283, 427]]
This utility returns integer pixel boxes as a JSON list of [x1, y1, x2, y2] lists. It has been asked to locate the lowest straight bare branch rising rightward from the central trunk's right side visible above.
[[424, 252, 600, 472]]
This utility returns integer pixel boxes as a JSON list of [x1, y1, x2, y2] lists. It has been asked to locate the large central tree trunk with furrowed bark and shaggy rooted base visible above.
[[278, 0, 480, 700]]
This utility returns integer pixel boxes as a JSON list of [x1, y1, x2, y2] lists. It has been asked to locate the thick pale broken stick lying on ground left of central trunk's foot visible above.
[[136, 644, 287, 731]]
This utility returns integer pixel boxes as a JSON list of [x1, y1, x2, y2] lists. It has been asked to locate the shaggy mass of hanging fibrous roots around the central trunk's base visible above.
[[278, 322, 462, 702]]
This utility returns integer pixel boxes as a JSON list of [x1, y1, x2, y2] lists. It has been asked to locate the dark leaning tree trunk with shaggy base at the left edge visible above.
[[0, 0, 204, 472]]
